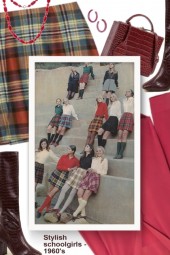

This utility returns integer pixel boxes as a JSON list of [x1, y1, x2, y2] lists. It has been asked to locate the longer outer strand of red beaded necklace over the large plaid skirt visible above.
[[2, 0, 51, 44]]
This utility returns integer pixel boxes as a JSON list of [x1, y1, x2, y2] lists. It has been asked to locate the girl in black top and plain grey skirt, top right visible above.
[[103, 63, 118, 105]]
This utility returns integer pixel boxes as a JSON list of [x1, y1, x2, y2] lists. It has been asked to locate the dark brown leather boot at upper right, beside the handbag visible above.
[[143, 0, 170, 92]]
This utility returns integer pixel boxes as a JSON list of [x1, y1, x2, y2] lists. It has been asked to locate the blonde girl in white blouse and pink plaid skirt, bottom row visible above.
[[73, 146, 108, 220]]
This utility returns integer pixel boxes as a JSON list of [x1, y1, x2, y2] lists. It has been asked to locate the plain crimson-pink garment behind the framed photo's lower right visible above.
[[81, 94, 170, 255]]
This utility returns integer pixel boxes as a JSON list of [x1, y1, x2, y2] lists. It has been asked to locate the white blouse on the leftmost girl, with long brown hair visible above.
[[35, 149, 59, 164]]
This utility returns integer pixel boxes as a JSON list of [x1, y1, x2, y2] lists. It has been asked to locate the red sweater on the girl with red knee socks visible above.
[[56, 155, 80, 171]]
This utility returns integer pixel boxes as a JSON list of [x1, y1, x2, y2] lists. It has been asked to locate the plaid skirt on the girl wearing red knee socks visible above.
[[48, 170, 69, 190]]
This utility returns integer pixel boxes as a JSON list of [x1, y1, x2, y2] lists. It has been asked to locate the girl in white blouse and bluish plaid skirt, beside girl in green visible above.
[[53, 98, 78, 147]]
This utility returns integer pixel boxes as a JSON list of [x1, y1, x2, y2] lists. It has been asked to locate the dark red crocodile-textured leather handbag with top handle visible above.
[[102, 14, 163, 76]]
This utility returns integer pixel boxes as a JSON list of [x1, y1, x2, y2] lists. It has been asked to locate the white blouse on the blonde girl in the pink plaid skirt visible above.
[[91, 157, 108, 175]]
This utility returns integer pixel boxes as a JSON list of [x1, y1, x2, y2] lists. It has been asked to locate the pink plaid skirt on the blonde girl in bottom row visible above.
[[79, 171, 100, 193]]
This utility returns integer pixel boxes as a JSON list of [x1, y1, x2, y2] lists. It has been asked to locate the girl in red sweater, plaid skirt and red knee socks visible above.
[[37, 145, 79, 218]]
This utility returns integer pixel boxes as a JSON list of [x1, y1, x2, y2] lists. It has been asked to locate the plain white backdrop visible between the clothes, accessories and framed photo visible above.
[[0, 0, 166, 255]]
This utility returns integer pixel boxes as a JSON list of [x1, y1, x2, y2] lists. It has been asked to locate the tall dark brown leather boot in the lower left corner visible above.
[[0, 152, 41, 255]]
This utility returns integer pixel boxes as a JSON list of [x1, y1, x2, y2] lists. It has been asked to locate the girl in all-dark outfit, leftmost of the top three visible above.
[[67, 67, 79, 99]]
